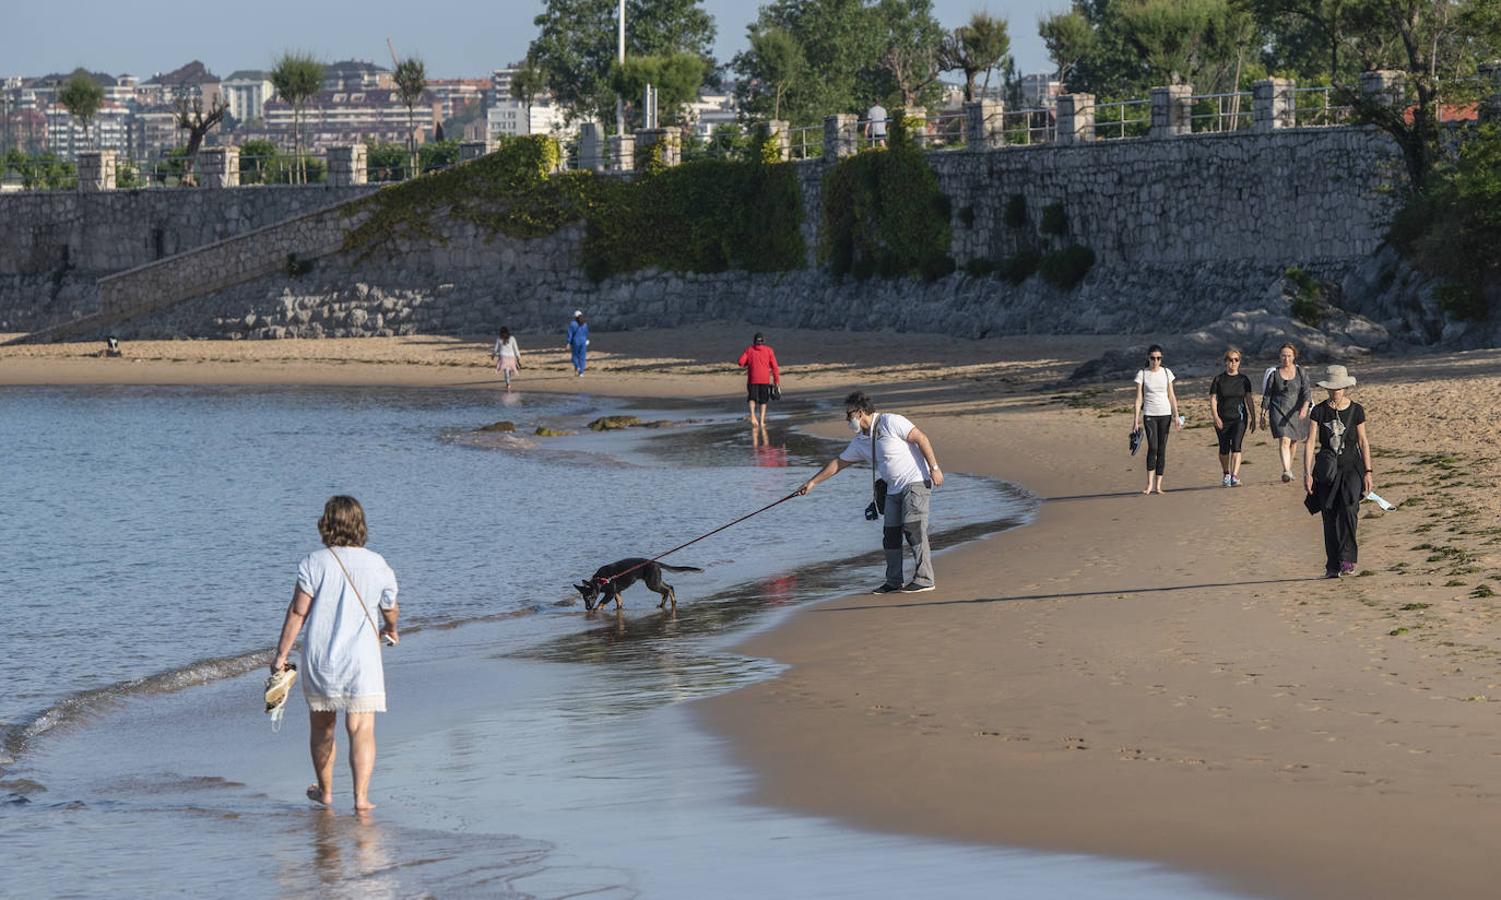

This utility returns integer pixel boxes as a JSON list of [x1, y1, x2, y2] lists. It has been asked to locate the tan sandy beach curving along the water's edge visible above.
[[0, 324, 1501, 897]]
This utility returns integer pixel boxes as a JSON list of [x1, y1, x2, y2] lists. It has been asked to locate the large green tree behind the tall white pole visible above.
[[527, 0, 714, 120]]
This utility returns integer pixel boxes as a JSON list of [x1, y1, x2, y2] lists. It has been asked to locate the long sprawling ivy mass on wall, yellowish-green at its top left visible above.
[[344, 137, 806, 281]]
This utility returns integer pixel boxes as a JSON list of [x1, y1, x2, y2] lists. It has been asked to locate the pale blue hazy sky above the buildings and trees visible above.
[[0, 0, 1067, 78]]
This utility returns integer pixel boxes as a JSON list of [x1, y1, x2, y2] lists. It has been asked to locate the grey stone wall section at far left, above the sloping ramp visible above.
[[0, 186, 374, 332]]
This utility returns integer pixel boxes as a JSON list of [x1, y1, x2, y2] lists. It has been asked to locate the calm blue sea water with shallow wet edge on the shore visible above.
[[0, 389, 1242, 897]]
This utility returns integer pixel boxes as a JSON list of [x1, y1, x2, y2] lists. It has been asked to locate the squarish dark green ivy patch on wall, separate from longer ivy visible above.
[[820, 116, 955, 279]]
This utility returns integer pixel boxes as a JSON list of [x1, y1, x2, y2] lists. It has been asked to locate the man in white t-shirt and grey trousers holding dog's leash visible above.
[[797, 390, 943, 594]]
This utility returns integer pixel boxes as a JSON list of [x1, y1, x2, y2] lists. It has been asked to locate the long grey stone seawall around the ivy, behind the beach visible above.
[[8, 128, 1400, 338]]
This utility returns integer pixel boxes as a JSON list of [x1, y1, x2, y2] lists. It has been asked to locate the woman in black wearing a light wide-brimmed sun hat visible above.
[[1303, 366, 1373, 578]]
